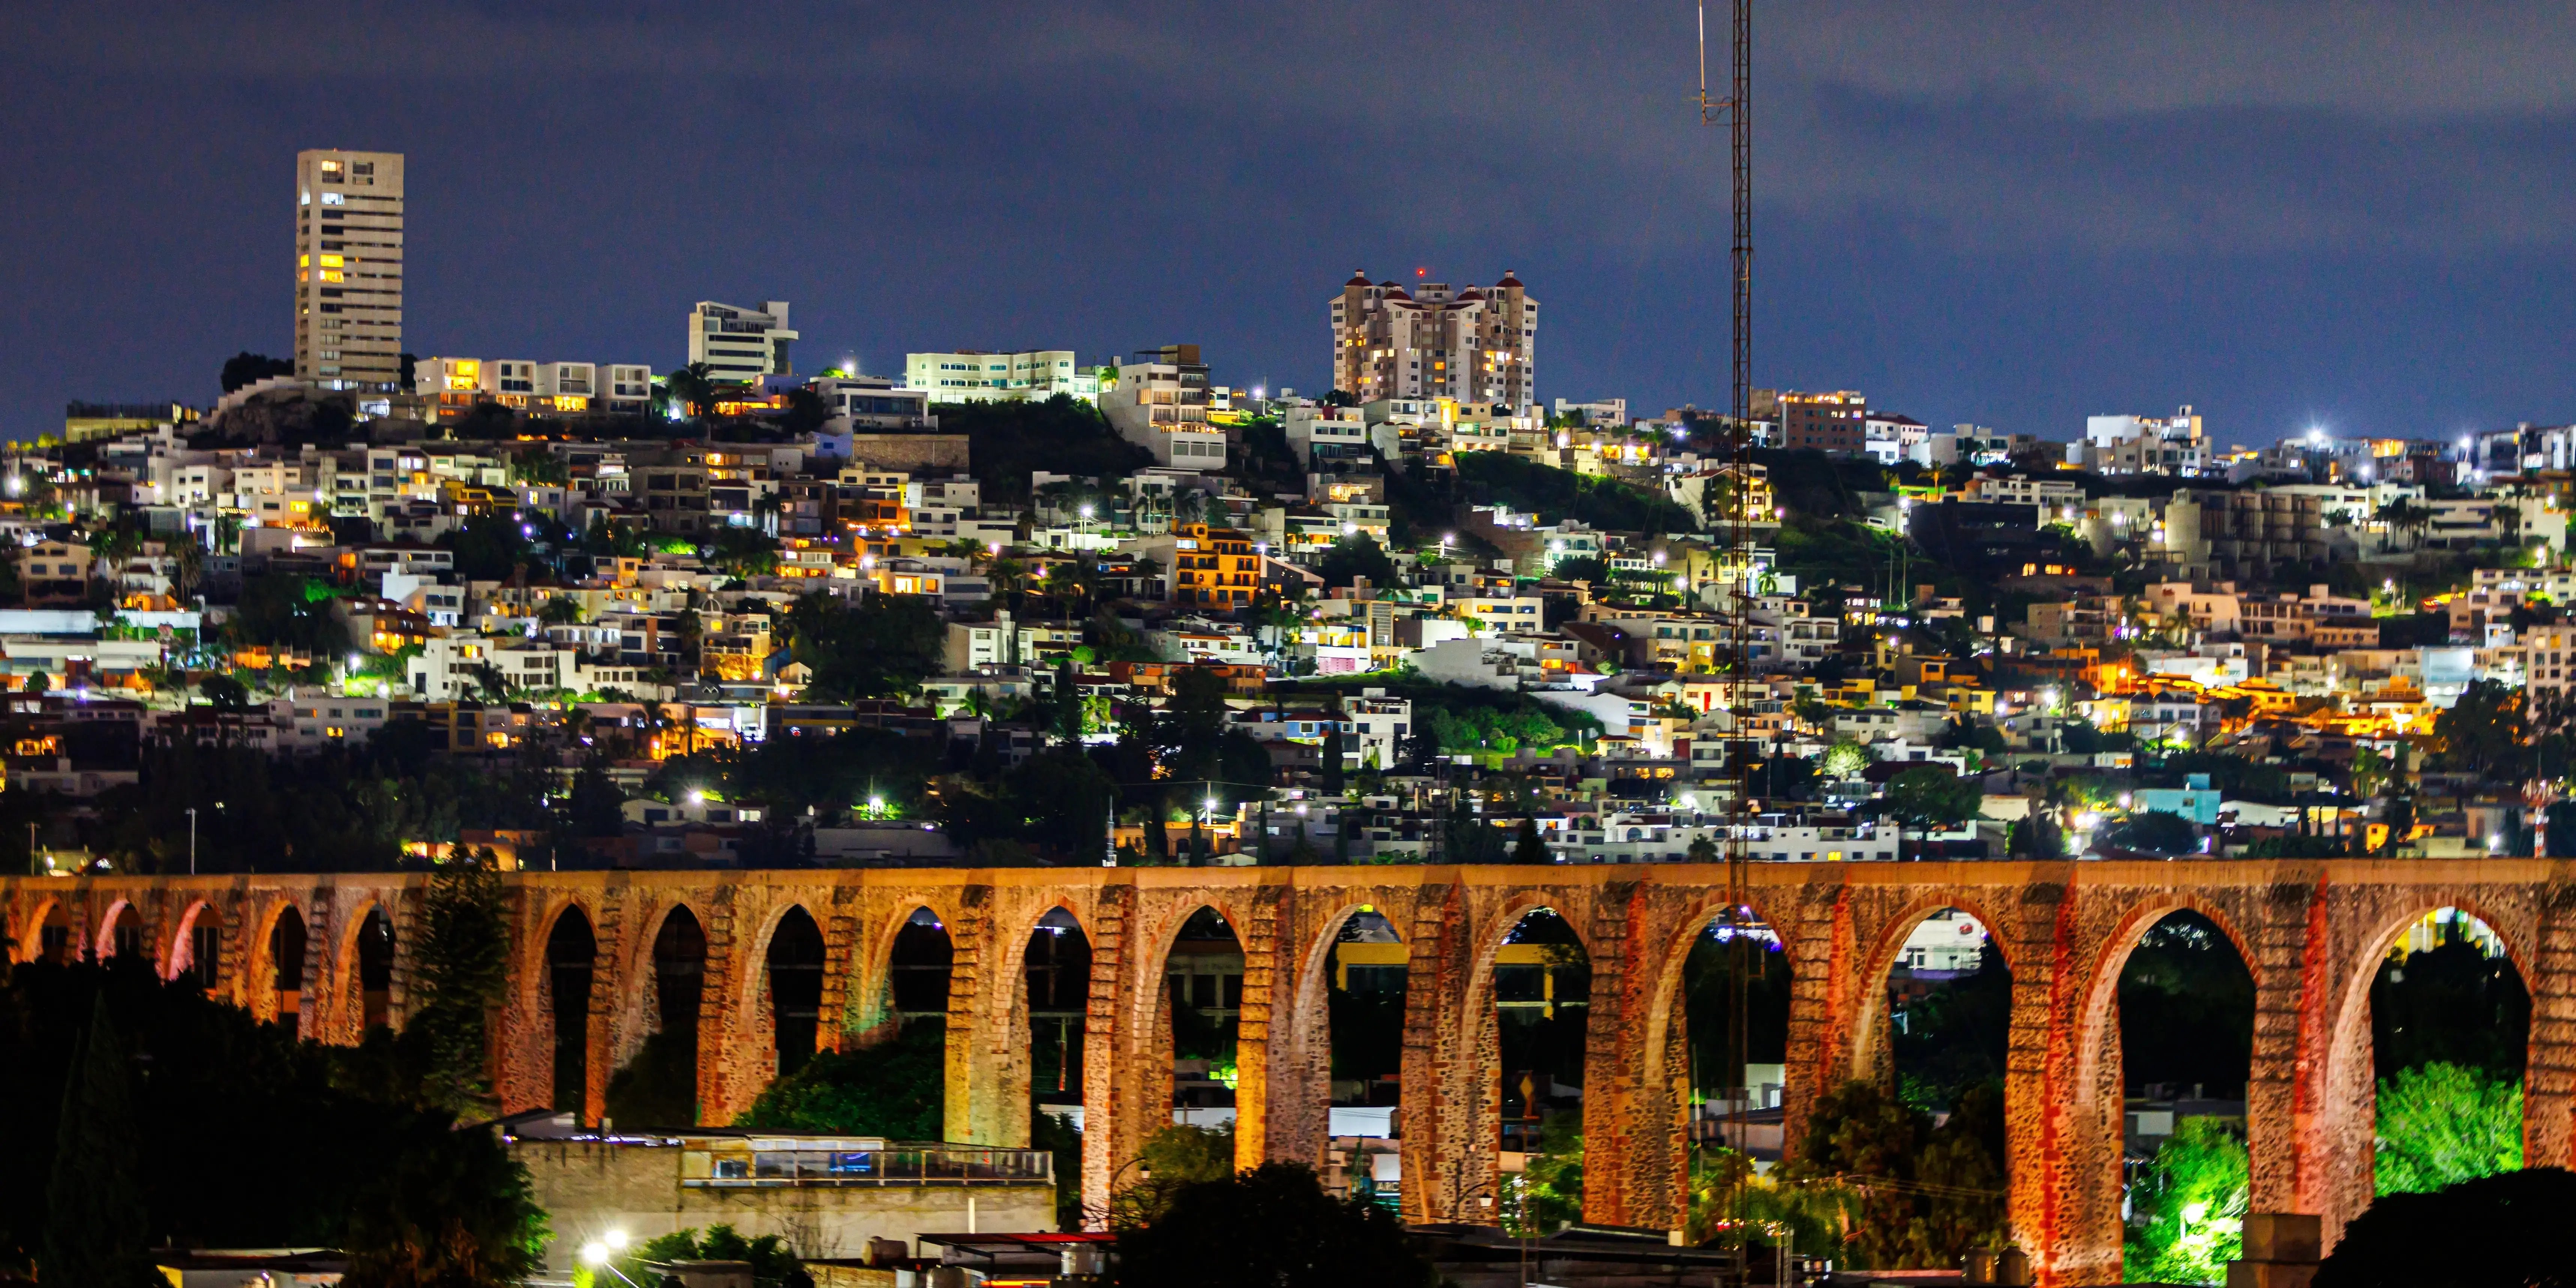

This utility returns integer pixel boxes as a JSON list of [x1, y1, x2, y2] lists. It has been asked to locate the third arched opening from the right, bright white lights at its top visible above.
[[1888, 907, 2012, 1116]]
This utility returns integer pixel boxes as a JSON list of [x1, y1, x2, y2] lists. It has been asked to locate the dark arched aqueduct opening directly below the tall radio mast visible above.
[[1682, 907, 1790, 1162]]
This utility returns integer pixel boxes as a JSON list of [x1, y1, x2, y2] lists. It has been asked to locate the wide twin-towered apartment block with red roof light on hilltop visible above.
[[1332, 270, 1538, 412]]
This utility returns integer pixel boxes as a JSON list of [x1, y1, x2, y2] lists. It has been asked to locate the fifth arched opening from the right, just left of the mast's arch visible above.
[[1494, 907, 1592, 1159]]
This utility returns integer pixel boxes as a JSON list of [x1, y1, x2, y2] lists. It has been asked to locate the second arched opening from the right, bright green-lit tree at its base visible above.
[[2117, 909, 2254, 1283]]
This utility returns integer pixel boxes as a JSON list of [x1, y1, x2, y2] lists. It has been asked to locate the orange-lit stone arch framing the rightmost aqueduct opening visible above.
[[2321, 889, 2537, 1249]]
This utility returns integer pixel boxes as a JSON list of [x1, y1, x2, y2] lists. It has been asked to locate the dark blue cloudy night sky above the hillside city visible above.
[[0, 0, 2576, 443]]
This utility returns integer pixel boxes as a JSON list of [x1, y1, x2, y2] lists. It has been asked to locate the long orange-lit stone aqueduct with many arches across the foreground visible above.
[[0, 861, 2576, 1285]]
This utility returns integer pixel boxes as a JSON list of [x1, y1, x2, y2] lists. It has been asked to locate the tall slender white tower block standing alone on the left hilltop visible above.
[[296, 149, 402, 391]]
